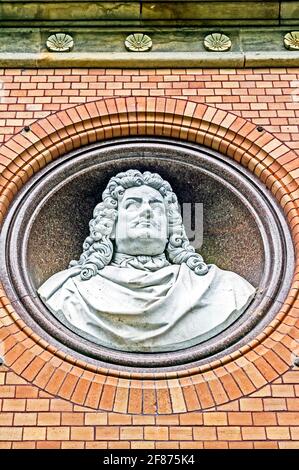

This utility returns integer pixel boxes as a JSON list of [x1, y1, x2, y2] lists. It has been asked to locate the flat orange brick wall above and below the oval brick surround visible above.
[[0, 68, 299, 449]]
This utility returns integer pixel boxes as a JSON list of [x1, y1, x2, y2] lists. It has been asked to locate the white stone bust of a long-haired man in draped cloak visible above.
[[38, 170, 256, 352]]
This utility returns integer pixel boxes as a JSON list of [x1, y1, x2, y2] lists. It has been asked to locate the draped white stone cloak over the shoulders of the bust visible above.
[[38, 264, 256, 352]]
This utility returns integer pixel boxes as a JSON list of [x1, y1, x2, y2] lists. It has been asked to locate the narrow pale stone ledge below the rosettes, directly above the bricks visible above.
[[0, 51, 299, 68]]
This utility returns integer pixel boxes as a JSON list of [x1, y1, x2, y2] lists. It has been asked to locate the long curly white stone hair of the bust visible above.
[[69, 170, 208, 280]]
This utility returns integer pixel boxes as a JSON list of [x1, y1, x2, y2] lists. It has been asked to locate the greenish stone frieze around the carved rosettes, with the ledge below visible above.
[[0, 27, 299, 68]]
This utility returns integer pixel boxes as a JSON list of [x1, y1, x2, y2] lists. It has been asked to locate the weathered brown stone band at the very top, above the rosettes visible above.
[[0, 0, 286, 26]]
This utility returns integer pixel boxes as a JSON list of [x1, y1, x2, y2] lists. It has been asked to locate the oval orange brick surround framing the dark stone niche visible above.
[[0, 97, 299, 414]]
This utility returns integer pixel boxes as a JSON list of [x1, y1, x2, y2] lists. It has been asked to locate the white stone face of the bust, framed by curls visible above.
[[115, 185, 167, 256]]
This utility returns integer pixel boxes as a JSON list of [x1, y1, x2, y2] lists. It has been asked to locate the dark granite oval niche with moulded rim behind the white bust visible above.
[[0, 138, 294, 371]]
